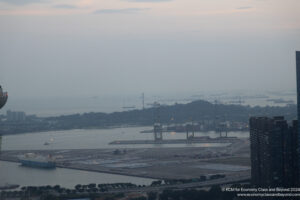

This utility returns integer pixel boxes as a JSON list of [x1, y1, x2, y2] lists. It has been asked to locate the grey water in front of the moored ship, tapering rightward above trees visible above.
[[0, 161, 153, 188]]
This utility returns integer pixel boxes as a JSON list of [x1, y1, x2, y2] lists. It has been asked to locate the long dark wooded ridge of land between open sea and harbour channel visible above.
[[0, 100, 297, 134]]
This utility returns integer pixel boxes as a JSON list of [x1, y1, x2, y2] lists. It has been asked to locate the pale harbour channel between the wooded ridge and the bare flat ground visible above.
[[2, 127, 249, 150]]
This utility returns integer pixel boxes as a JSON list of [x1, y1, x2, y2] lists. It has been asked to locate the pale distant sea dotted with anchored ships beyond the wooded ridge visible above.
[[0, 91, 297, 117]]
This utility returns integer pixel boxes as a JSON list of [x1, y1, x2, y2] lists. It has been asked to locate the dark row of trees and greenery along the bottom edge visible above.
[[0, 184, 250, 200]]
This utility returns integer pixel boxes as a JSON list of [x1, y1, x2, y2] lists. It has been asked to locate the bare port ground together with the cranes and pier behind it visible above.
[[0, 99, 250, 183]]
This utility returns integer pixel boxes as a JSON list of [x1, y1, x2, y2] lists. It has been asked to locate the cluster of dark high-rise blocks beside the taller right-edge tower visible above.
[[250, 117, 298, 187]]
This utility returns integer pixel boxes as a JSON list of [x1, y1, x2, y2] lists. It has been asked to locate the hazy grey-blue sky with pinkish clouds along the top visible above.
[[0, 0, 300, 97]]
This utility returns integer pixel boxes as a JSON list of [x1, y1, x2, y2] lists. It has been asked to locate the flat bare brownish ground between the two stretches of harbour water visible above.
[[0, 139, 250, 179]]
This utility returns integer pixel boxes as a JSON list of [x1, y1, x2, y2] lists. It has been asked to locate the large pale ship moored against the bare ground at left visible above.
[[18, 153, 56, 169]]
